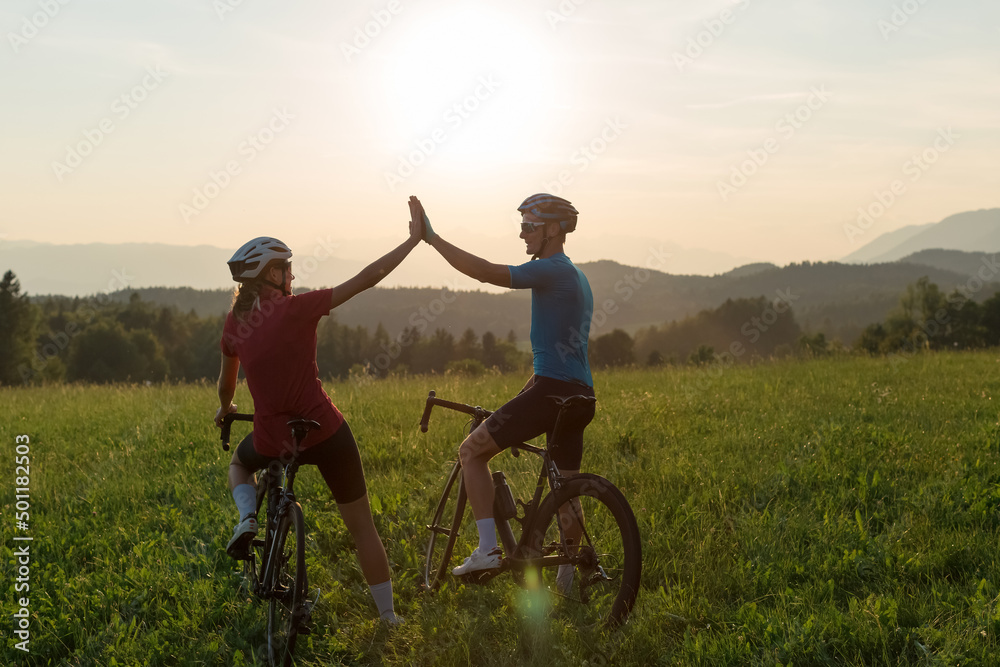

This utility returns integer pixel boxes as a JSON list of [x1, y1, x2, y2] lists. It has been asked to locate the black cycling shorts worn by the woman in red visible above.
[[236, 421, 368, 505]]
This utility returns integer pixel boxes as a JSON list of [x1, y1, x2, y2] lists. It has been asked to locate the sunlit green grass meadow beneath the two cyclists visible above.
[[0, 352, 1000, 666]]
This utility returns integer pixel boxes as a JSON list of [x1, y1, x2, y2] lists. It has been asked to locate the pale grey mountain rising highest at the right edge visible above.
[[842, 208, 1000, 264]]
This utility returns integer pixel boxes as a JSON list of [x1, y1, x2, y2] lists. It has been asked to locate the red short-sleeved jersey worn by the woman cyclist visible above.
[[220, 289, 344, 456]]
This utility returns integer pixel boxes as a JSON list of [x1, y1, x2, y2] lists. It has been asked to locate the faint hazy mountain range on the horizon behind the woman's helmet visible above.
[[0, 233, 751, 296]]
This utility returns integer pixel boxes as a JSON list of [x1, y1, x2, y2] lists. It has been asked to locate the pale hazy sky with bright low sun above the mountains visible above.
[[0, 0, 1000, 279]]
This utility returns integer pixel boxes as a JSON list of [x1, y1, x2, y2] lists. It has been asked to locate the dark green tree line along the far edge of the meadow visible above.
[[0, 271, 1000, 385]]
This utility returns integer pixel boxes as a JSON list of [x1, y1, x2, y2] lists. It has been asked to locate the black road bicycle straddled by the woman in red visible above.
[[221, 413, 319, 667]]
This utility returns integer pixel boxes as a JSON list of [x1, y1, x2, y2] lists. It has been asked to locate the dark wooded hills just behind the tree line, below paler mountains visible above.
[[58, 258, 1000, 350]]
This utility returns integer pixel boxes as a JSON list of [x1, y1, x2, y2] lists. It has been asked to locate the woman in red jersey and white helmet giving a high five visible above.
[[215, 221, 421, 625]]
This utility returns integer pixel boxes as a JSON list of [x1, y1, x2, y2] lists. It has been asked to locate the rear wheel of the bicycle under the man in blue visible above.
[[527, 474, 642, 628]]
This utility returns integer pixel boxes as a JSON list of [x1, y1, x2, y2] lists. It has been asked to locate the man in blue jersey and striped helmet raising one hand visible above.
[[410, 194, 594, 590]]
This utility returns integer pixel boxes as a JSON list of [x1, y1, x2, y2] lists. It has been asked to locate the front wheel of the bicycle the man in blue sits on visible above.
[[424, 462, 476, 590]]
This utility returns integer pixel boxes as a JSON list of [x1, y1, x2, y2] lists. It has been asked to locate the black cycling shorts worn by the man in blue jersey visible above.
[[484, 375, 594, 470]]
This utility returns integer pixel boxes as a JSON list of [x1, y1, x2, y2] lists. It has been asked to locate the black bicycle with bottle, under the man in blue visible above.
[[420, 391, 642, 629]]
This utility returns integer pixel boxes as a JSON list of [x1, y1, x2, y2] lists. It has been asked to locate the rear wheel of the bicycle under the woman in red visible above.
[[267, 503, 307, 667]]
